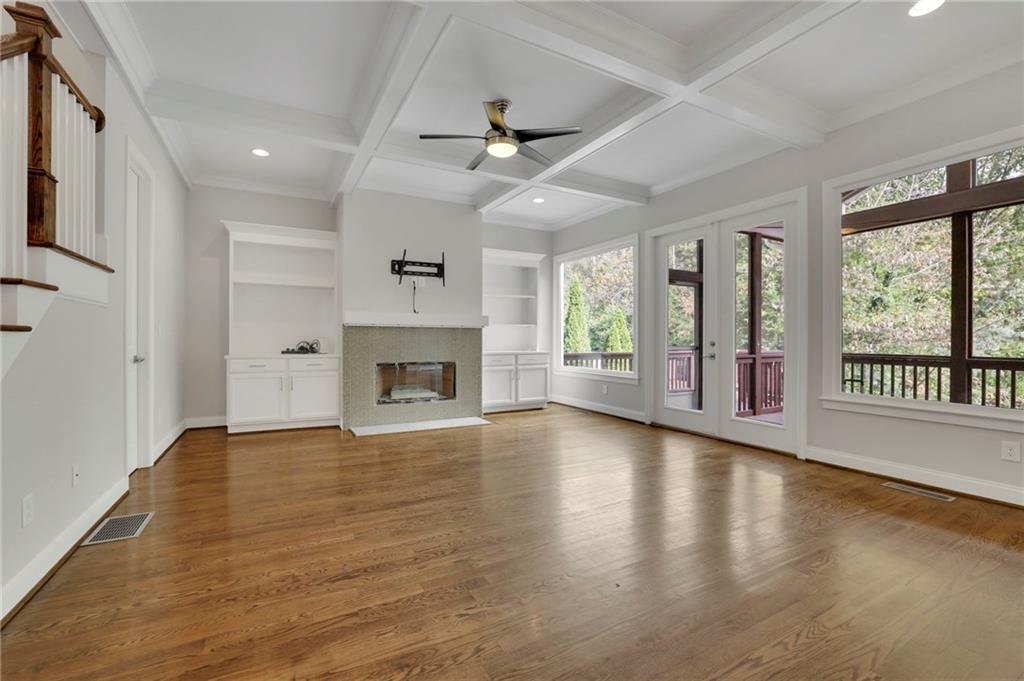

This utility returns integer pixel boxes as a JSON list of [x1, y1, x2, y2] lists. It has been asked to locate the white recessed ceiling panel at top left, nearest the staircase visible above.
[[127, 2, 393, 124]]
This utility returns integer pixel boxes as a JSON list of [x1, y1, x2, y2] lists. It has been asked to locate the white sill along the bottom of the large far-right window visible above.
[[820, 394, 1024, 434]]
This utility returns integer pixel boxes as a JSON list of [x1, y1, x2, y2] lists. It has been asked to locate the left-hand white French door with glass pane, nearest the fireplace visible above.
[[652, 225, 721, 436]]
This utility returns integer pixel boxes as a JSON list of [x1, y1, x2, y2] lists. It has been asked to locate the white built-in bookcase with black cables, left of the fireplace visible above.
[[224, 220, 341, 433]]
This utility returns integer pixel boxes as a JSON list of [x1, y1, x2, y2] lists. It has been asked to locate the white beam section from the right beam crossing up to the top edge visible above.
[[686, 0, 857, 92]]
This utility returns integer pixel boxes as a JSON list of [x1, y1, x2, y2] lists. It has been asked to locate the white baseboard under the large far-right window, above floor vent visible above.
[[807, 446, 1024, 506]]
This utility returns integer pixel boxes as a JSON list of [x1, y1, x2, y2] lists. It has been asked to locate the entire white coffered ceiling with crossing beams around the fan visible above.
[[75, 0, 1024, 229]]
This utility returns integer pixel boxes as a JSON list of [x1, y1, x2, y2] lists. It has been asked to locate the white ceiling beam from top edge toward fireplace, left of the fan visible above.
[[338, 5, 451, 194]]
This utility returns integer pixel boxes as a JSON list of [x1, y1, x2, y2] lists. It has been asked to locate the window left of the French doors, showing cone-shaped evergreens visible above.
[[558, 241, 630, 377]]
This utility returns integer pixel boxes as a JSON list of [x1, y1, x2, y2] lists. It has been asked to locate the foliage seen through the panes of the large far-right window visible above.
[[843, 147, 1024, 364]]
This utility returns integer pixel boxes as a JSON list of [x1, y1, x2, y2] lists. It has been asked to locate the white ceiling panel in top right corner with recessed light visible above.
[[743, 2, 1024, 114]]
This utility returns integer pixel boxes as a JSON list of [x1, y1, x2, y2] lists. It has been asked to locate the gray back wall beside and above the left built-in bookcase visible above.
[[184, 185, 335, 421]]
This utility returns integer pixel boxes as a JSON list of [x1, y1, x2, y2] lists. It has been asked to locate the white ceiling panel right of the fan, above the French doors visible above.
[[573, 104, 783, 191]]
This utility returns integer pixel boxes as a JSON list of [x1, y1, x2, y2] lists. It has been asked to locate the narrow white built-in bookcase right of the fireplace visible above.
[[482, 248, 551, 412]]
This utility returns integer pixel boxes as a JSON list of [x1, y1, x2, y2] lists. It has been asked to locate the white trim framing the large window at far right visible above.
[[819, 127, 1024, 433]]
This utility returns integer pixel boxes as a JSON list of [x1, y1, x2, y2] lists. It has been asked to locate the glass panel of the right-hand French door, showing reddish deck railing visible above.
[[733, 233, 785, 424]]
